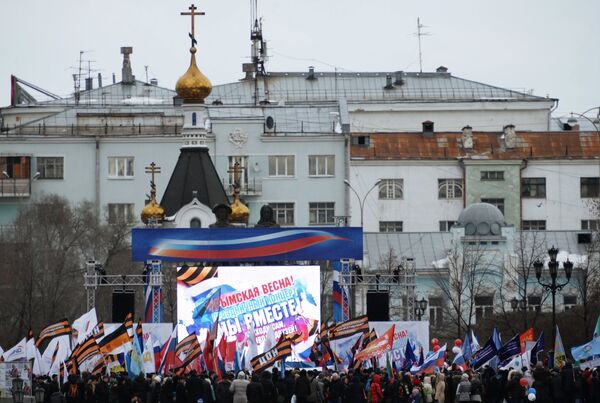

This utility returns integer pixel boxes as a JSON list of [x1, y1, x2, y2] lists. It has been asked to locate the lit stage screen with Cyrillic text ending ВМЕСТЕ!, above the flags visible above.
[[177, 266, 321, 362]]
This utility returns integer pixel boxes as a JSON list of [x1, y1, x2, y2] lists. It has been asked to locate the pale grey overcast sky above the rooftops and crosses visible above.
[[0, 0, 600, 116]]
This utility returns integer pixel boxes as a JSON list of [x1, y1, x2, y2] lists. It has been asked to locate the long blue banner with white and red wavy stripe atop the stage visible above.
[[132, 227, 363, 262]]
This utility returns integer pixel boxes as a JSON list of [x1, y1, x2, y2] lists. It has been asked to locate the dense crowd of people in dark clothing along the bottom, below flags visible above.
[[34, 362, 600, 403]]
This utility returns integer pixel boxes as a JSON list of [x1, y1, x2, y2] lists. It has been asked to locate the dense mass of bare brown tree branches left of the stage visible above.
[[0, 195, 128, 342]]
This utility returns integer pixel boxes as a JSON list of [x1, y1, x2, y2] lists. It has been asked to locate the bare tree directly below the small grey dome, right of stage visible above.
[[434, 240, 501, 338]]
